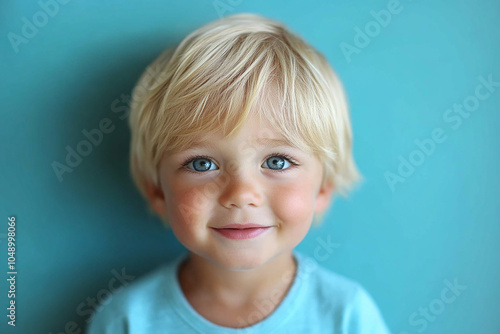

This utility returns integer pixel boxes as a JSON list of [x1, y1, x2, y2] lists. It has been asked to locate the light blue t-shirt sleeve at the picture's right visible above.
[[342, 286, 390, 334]]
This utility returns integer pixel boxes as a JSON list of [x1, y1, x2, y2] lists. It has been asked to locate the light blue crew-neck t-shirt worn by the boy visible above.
[[87, 250, 389, 334]]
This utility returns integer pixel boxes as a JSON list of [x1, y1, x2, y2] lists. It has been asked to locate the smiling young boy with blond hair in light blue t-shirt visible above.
[[87, 14, 389, 334]]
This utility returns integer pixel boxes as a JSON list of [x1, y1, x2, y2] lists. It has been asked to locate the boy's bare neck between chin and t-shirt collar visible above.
[[179, 251, 297, 307]]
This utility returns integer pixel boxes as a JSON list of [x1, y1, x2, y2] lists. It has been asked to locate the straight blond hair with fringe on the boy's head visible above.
[[129, 13, 361, 224]]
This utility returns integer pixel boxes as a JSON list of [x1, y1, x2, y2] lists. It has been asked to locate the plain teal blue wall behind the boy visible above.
[[0, 0, 500, 334]]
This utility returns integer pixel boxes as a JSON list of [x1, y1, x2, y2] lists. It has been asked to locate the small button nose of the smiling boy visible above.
[[219, 174, 263, 209]]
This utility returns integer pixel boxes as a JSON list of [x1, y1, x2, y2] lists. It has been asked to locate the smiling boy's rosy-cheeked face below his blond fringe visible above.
[[149, 112, 333, 269]]
